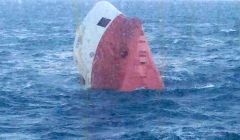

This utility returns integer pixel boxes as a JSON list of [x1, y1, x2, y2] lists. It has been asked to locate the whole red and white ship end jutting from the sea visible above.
[[74, 1, 164, 91]]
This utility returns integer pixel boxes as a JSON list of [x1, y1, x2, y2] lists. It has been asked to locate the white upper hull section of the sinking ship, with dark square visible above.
[[74, 1, 121, 88]]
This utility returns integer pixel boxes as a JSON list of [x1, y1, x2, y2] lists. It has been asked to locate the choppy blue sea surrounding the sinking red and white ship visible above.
[[0, 0, 240, 140]]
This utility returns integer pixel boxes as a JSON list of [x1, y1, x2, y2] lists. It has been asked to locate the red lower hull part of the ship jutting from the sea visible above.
[[91, 15, 164, 91]]
